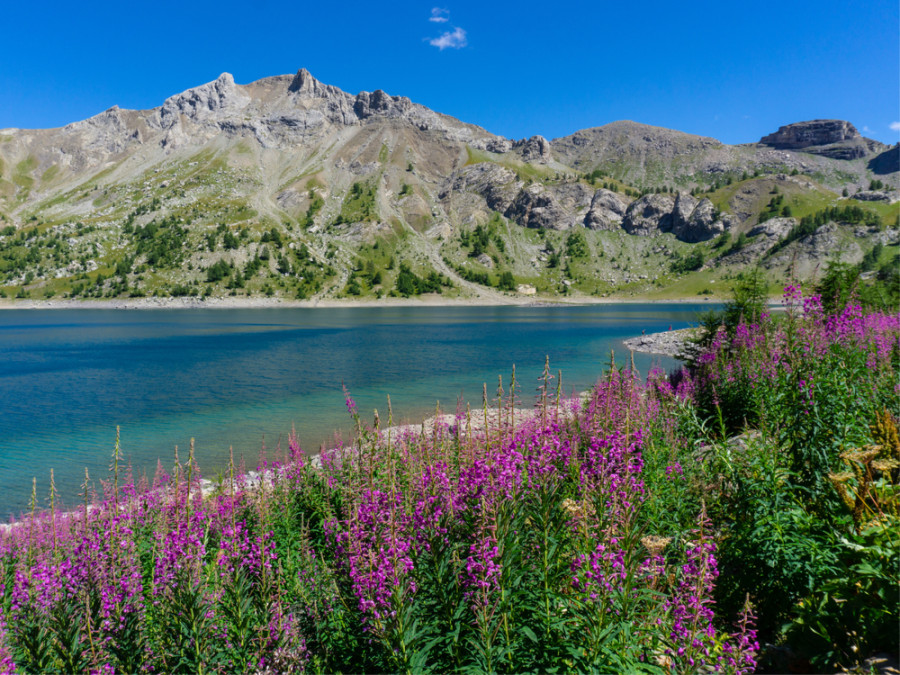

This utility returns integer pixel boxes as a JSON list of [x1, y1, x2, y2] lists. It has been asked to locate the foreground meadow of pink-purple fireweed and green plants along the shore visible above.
[[0, 287, 900, 674]]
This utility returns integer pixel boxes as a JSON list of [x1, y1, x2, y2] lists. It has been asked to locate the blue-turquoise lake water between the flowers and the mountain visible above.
[[0, 304, 709, 517]]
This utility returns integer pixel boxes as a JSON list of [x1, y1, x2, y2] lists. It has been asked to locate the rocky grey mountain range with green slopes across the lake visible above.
[[0, 70, 900, 298]]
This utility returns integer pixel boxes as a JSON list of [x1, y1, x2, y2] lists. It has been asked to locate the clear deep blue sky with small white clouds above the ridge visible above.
[[0, 0, 900, 143]]
